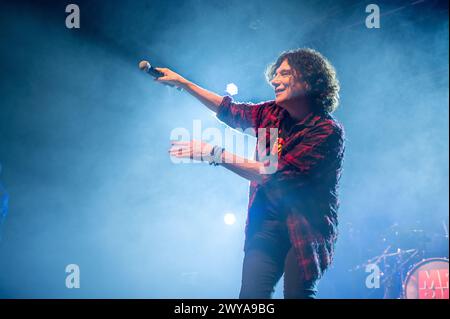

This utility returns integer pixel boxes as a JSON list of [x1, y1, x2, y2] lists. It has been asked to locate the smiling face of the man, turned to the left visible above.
[[271, 60, 306, 106]]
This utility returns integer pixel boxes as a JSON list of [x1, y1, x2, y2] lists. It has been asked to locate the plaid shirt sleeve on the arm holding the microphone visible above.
[[216, 96, 267, 130]]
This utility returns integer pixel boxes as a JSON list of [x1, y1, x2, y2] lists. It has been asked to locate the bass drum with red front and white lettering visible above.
[[403, 258, 449, 299]]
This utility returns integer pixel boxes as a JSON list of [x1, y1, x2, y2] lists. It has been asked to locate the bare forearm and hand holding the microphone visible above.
[[155, 68, 223, 113]]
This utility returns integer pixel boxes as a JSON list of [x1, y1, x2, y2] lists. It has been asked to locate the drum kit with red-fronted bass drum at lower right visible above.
[[352, 222, 449, 300]]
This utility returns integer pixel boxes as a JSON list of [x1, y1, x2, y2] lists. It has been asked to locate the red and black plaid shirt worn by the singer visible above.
[[217, 96, 344, 280]]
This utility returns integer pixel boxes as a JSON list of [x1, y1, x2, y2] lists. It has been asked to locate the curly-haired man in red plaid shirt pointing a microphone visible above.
[[155, 49, 344, 299]]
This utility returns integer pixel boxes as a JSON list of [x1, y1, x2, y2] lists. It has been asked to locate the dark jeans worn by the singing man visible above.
[[239, 222, 317, 299]]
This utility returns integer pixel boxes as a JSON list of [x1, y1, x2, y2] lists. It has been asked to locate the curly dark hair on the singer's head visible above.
[[266, 48, 340, 113]]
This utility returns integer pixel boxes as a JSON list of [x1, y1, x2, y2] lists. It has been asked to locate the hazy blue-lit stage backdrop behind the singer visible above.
[[0, 0, 449, 298]]
